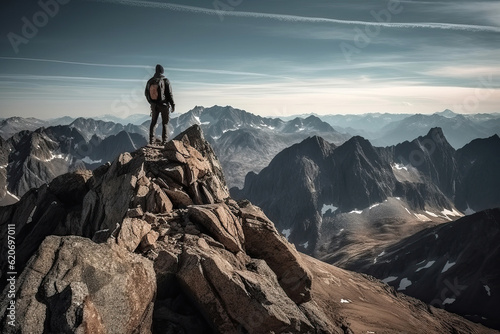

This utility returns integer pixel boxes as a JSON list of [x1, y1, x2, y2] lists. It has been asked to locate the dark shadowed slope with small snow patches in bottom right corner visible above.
[[344, 208, 500, 329]]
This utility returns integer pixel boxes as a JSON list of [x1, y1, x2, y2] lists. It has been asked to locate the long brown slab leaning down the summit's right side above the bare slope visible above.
[[236, 202, 312, 304]]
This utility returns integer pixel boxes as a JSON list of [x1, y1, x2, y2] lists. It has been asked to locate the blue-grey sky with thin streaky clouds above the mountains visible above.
[[0, 0, 500, 119]]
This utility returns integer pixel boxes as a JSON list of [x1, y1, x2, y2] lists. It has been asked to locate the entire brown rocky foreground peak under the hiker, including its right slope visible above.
[[0, 126, 497, 334]]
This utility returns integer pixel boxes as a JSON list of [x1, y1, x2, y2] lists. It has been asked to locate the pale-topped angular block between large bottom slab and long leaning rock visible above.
[[188, 203, 245, 253]]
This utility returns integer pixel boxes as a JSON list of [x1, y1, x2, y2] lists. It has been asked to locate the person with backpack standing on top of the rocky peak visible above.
[[144, 64, 175, 145]]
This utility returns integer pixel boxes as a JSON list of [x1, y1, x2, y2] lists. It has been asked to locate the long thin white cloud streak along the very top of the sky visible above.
[[91, 0, 500, 32]]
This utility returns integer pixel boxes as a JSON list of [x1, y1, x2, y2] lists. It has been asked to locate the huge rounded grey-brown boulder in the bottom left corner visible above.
[[2, 236, 156, 334]]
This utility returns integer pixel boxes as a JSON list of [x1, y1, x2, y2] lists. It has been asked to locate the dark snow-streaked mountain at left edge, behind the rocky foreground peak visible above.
[[0, 120, 147, 205]]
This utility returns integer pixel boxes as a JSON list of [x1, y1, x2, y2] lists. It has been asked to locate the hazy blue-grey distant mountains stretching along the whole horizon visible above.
[[0, 106, 500, 196]]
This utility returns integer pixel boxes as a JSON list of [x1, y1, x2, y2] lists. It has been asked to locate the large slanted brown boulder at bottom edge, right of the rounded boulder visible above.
[[178, 237, 312, 333]]
